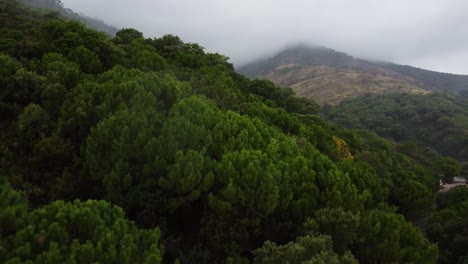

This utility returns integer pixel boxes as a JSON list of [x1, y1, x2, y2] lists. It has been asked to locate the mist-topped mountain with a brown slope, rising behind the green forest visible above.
[[237, 44, 468, 105]]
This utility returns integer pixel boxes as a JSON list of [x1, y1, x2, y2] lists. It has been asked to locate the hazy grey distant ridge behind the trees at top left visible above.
[[19, 0, 118, 37]]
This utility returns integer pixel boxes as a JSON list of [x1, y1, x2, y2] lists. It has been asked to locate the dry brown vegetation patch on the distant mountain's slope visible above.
[[259, 63, 430, 105]]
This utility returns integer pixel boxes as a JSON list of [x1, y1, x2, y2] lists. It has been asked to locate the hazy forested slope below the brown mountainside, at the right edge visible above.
[[322, 93, 468, 176]]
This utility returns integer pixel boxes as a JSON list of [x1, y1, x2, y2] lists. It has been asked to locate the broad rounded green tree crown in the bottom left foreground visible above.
[[10, 201, 161, 263]]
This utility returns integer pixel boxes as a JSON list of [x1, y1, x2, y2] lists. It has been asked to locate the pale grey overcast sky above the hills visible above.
[[62, 0, 468, 74]]
